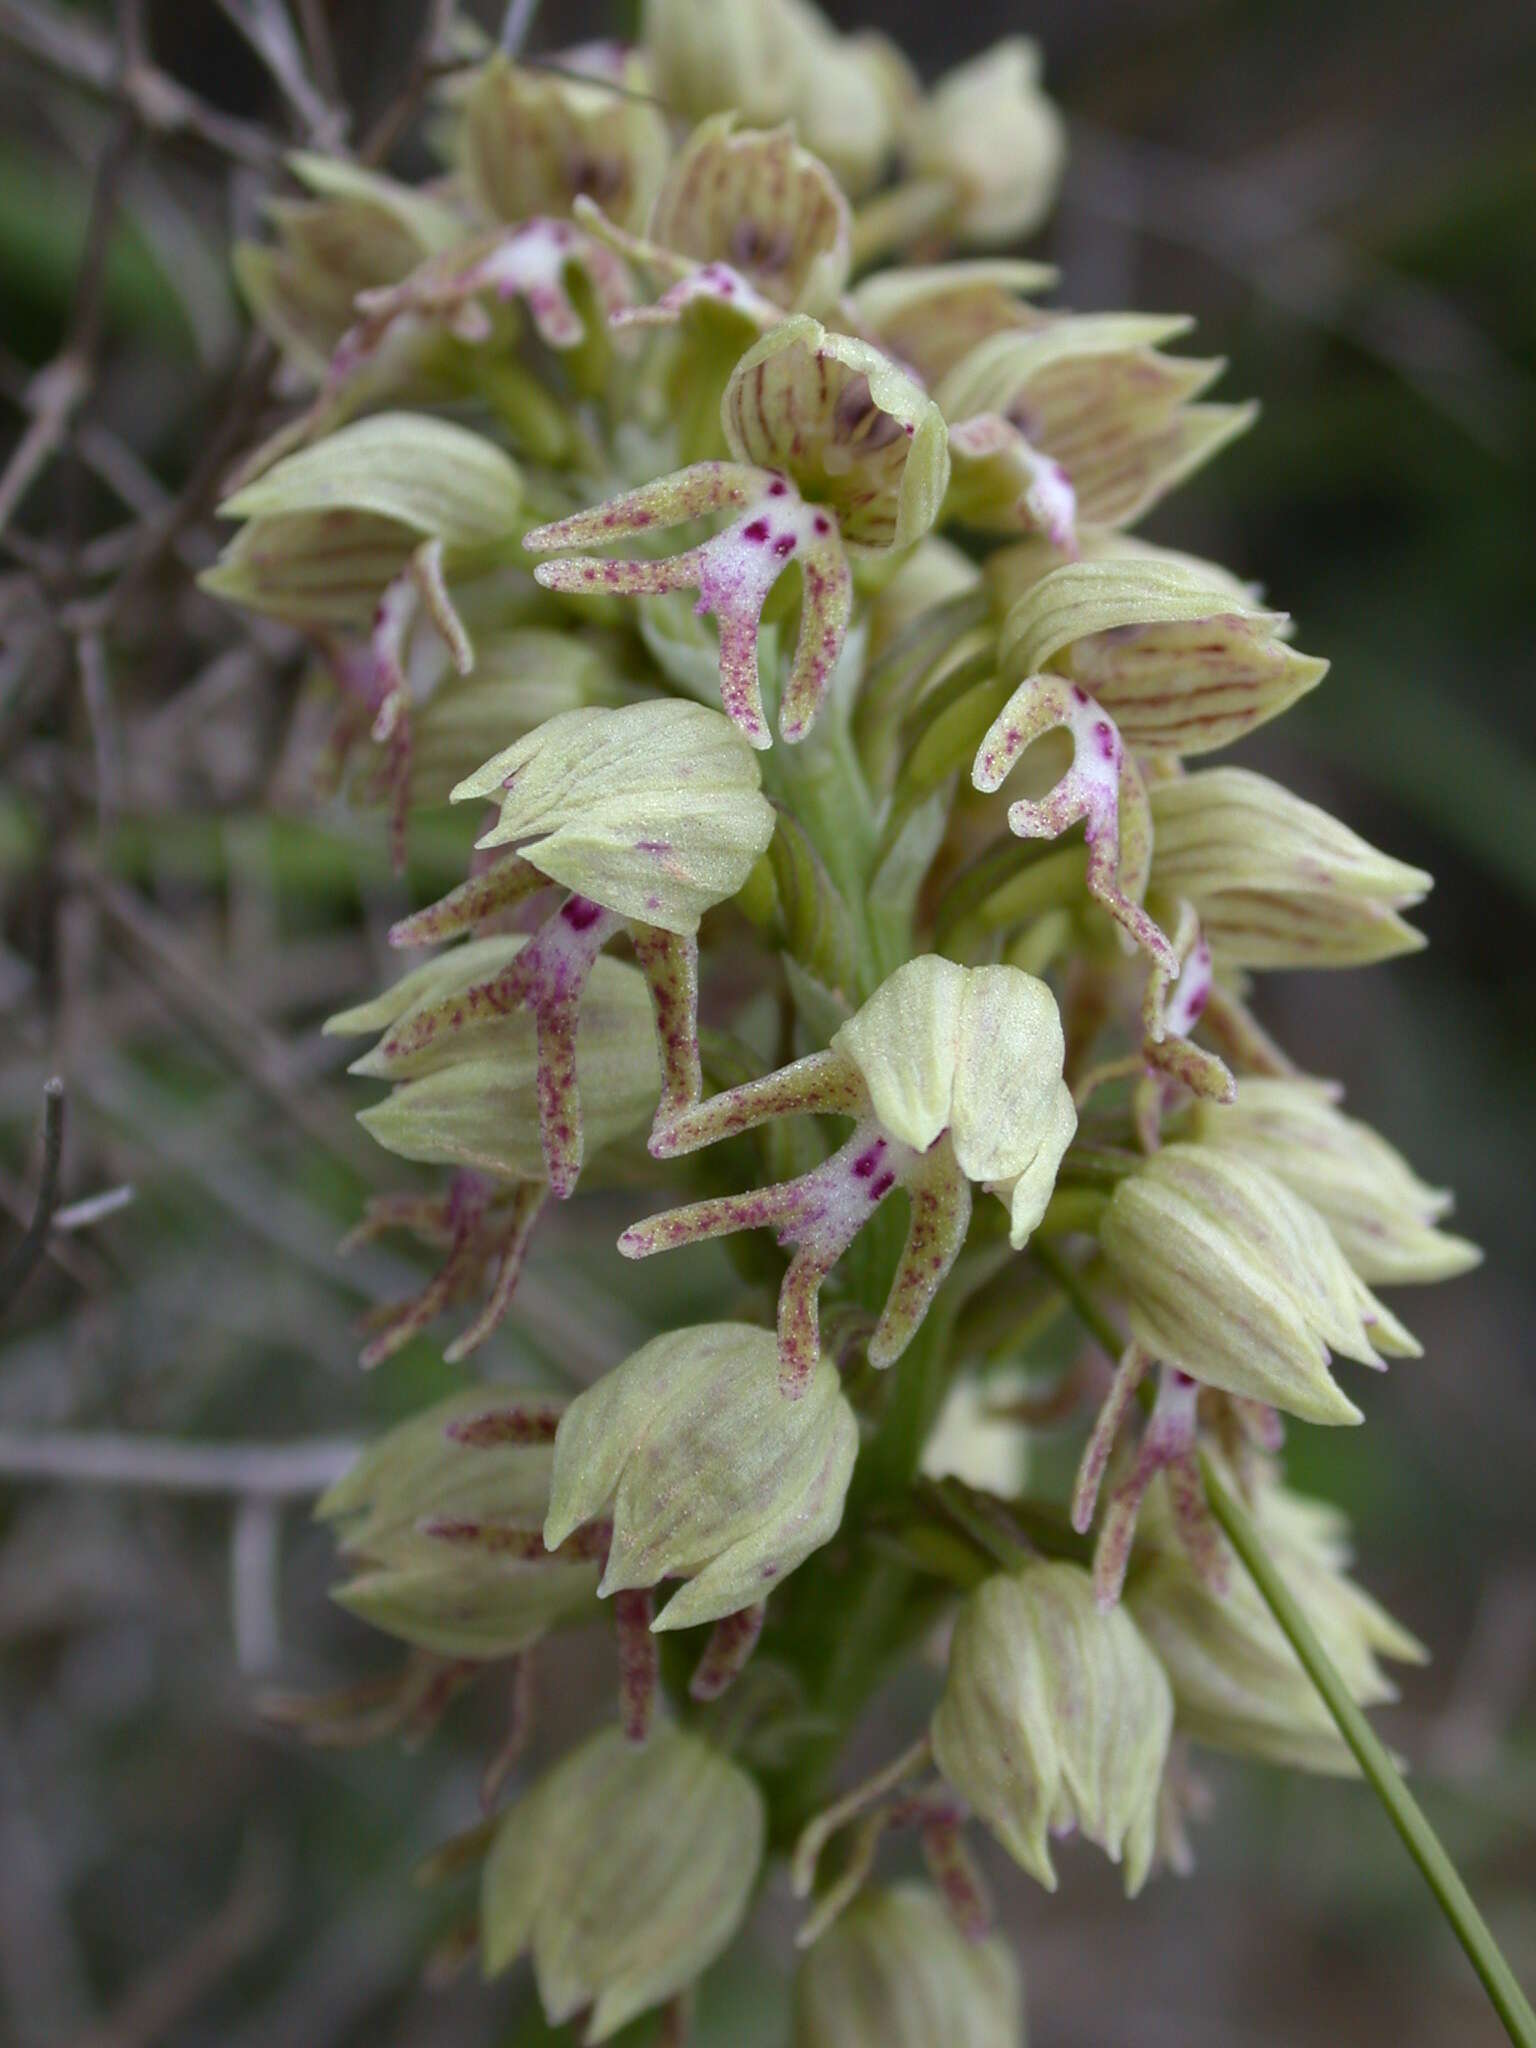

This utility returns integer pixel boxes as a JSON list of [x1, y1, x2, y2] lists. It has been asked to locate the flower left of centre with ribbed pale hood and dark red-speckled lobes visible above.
[[383, 698, 774, 1198]]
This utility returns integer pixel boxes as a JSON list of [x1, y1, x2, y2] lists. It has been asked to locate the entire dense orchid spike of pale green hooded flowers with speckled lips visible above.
[[217, 0, 1477, 2048]]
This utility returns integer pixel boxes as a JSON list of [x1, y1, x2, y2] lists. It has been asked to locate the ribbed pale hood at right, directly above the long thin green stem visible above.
[[1100, 1145, 1417, 1423]]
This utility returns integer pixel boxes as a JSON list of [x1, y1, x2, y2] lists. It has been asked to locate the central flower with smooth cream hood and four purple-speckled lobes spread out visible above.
[[618, 954, 1077, 1395]]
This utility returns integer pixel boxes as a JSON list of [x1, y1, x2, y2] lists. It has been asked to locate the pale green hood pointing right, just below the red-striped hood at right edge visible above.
[[1151, 768, 1432, 967]]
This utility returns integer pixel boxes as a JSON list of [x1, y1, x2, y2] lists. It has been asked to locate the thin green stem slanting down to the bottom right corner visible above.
[[1030, 1243, 1536, 2048]]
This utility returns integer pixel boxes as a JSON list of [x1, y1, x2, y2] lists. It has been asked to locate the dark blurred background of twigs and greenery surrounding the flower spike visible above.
[[0, 0, 1536, 2048]]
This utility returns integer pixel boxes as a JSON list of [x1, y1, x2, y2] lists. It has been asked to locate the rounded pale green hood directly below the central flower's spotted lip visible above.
[[545, 1323, 858, 1628]]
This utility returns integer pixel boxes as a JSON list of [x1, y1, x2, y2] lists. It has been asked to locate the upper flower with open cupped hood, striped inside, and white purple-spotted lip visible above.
[[524, 315, 948, 748]]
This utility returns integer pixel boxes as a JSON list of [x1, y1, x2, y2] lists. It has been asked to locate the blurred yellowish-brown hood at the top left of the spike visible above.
[[461, 43, 672, 227]]
